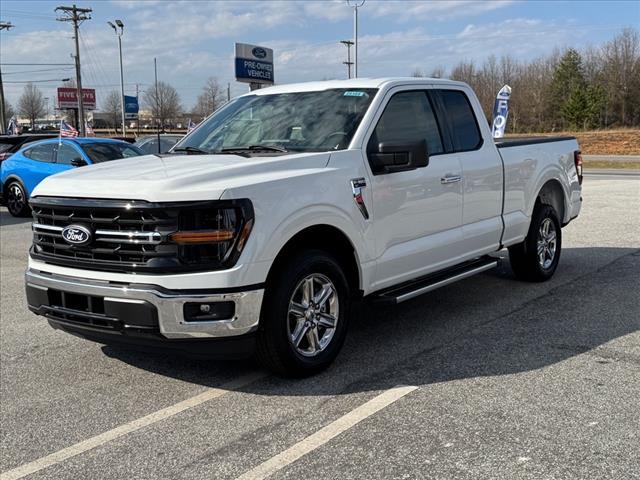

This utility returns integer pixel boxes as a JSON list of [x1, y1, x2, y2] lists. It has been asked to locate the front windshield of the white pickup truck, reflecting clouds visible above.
[[173, 88, 377, 153]]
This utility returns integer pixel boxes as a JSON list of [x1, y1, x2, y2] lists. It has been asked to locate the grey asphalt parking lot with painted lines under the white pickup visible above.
[[0, 173, 640, 480]]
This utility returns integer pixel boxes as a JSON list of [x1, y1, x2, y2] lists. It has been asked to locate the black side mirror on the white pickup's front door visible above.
[[367, 140, 429, 175]]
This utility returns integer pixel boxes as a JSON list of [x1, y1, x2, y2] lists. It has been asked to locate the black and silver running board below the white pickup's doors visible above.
[[371, 257, 500, 304]]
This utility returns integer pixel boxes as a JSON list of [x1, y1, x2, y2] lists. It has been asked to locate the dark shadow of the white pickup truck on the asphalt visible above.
[[103, 248, 640, 396]]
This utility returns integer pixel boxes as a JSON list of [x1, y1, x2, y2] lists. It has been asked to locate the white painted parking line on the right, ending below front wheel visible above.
[[236, 386, 418, 480]]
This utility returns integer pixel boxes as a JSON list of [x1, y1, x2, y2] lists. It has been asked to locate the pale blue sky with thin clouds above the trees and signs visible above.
[[0, 0, 640, 108]]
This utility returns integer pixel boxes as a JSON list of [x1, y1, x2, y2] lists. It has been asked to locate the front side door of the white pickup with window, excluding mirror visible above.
[[367, 85, 462, 289]]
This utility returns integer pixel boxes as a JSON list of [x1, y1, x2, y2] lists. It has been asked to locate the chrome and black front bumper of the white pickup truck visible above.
[[25, 268, 264, 340]]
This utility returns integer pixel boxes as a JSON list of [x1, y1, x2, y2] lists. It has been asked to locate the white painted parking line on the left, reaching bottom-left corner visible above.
[[0, 373, 266, 480]]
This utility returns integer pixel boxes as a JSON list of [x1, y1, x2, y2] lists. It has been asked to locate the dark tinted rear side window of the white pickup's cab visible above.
[[440, 90, 482, 152]]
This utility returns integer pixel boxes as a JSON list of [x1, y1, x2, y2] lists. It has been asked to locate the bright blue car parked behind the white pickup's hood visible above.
[[0, 138, 144, 217]]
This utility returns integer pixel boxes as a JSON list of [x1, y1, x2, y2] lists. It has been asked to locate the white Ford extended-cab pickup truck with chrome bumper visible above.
[[26, 78, 582, 376]]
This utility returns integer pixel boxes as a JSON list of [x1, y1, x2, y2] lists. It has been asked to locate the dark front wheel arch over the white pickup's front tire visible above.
[[267, 224, 362, 295]]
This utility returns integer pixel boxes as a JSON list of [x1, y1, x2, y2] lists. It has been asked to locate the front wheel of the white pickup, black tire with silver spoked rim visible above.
[[257, 250, 350, 377]]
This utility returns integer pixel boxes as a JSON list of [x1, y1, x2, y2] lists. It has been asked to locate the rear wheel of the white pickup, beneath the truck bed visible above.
[[509, 203, 562, 282]]
